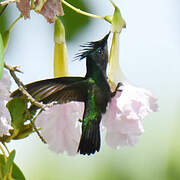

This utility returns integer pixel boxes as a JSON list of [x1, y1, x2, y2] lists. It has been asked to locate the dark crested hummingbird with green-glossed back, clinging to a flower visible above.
[[11, 33, 119, 155]]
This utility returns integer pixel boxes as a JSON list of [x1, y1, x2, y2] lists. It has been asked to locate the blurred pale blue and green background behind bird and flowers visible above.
[[0, 0, 180, 180]]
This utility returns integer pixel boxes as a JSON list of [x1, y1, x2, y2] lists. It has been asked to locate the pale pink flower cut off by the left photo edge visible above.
[[0, 71, 11, 136]]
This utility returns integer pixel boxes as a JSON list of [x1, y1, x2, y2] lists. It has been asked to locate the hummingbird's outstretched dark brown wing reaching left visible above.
[[11, 77, 88, 103]]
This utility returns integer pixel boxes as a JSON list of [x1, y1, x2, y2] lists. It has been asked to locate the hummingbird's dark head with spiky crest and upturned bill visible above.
[[77, 32, 110, 74]]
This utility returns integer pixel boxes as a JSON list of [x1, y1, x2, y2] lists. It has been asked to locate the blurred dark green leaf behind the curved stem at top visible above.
[[61, 0, 90, 40]]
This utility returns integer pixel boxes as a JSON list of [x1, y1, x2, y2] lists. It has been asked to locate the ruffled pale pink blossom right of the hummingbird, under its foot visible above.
[[102, 83, 158, 149]]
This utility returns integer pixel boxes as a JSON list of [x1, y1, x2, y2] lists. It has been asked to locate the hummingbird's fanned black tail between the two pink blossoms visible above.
[[78, 116, 101, 155]]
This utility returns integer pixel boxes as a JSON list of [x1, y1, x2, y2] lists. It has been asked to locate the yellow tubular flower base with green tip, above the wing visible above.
[[54, 18, 68, 77]]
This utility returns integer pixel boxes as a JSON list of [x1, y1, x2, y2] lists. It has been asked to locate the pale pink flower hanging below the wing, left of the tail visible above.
[[36, 102, 84, 155]]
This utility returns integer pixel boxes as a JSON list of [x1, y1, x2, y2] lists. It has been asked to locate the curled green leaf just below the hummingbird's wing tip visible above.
[[6, 98, 27, 129]]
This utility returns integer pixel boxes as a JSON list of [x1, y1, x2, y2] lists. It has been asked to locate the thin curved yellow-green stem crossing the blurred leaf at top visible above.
[[60, 0, 105, 19]]
